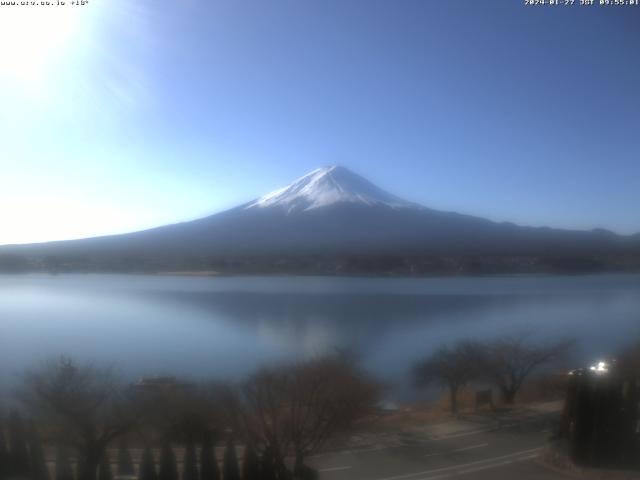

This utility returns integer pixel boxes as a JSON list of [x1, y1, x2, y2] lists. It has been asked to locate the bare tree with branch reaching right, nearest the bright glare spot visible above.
[[481, 333, 573, 404]]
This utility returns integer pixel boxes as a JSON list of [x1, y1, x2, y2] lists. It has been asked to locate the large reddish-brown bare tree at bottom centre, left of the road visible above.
[[235, 354, 379, 478]]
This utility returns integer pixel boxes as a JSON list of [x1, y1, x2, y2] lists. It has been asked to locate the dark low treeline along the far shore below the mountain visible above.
[[0, 250, 640, 276]]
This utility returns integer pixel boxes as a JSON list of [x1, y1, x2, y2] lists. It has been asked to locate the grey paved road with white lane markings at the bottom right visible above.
[[309, 404, 565, 480]]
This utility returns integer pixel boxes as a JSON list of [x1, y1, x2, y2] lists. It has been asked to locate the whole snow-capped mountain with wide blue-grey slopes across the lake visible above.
[[0, 166, 640, 269]]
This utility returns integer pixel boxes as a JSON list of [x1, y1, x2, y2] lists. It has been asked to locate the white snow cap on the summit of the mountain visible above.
[[245, 165, 422, 212]]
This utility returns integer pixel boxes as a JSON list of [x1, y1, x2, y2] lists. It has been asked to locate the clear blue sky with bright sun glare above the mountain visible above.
[[0, 0, 640, 244]]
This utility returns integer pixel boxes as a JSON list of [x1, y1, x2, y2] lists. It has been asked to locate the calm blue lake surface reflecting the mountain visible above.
[[0, 274, 640, 396]]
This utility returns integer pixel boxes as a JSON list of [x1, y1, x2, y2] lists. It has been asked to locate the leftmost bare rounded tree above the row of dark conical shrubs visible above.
[[21, 357, 140, 480]]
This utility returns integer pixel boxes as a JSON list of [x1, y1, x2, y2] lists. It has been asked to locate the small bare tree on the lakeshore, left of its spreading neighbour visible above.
[[413, 340, 483, 415]]
